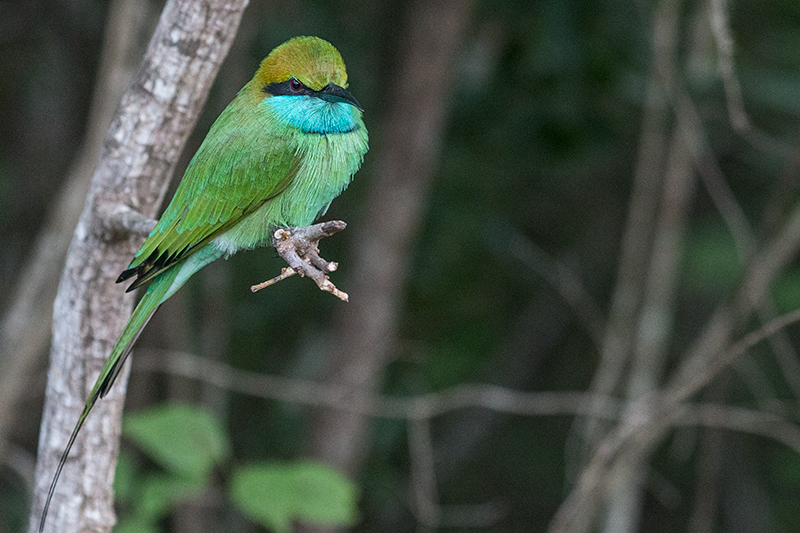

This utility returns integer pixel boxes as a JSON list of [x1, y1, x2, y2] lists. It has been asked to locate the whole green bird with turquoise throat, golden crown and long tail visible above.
[[39, 37, 367, 531]]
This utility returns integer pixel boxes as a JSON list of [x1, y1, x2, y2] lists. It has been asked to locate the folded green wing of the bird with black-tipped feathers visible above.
[[117, 122, 300, 291]]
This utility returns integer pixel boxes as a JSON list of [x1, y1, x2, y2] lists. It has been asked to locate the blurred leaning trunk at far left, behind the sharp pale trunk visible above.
[[0, 0, 153, 457]]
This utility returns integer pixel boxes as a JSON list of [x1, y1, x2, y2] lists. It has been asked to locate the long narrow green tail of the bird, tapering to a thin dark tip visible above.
[[39, 264, 181, 533]]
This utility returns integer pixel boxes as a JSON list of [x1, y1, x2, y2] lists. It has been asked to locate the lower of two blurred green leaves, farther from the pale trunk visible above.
[[230, 461, 358, 533]]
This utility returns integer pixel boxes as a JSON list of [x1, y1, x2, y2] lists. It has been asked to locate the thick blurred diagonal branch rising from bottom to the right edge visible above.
[[549, 193, 800, 533]]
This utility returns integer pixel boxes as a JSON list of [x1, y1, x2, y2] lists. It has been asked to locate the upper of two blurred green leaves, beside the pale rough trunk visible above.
[[123, 405, 228, 478]]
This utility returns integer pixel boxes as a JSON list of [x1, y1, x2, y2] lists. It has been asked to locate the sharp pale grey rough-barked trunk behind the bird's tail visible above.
[[29, 0, 247, 532]]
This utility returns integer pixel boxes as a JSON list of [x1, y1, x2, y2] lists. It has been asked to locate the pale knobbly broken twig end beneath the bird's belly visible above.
[[250, 220, 349, 302]]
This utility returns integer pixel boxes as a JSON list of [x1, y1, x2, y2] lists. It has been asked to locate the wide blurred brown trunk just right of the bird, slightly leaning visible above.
[[302, 0, 473, 502]]
